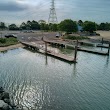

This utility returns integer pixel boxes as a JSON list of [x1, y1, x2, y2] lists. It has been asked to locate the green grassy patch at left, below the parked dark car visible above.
[[0, 38, 18, 47]]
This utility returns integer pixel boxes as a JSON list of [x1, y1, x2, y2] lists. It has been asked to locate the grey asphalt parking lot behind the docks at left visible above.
[[0, 31, 58, 41]]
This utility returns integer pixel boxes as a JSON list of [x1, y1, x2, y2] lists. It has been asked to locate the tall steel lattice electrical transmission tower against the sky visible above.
[[48, 0, 58, 24]]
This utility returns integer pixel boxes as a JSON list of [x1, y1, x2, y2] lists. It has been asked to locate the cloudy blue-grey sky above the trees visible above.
[[0, 0, 110, 24]]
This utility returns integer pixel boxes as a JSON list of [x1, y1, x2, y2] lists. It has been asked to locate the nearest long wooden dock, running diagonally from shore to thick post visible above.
[[22, 42, 76, 63]]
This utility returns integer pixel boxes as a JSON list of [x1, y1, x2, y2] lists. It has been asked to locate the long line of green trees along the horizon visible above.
[[0, 19, 110, 33]]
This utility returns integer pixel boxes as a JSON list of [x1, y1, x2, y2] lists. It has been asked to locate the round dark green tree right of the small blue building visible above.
[[83, 21, 96, 33]]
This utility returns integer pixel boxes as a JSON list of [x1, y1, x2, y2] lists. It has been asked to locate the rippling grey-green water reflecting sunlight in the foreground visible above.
[[0, 48, 110, 110]]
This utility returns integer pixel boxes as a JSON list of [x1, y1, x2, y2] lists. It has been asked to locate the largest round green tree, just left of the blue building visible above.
[[58, 19, 78, 33]]
